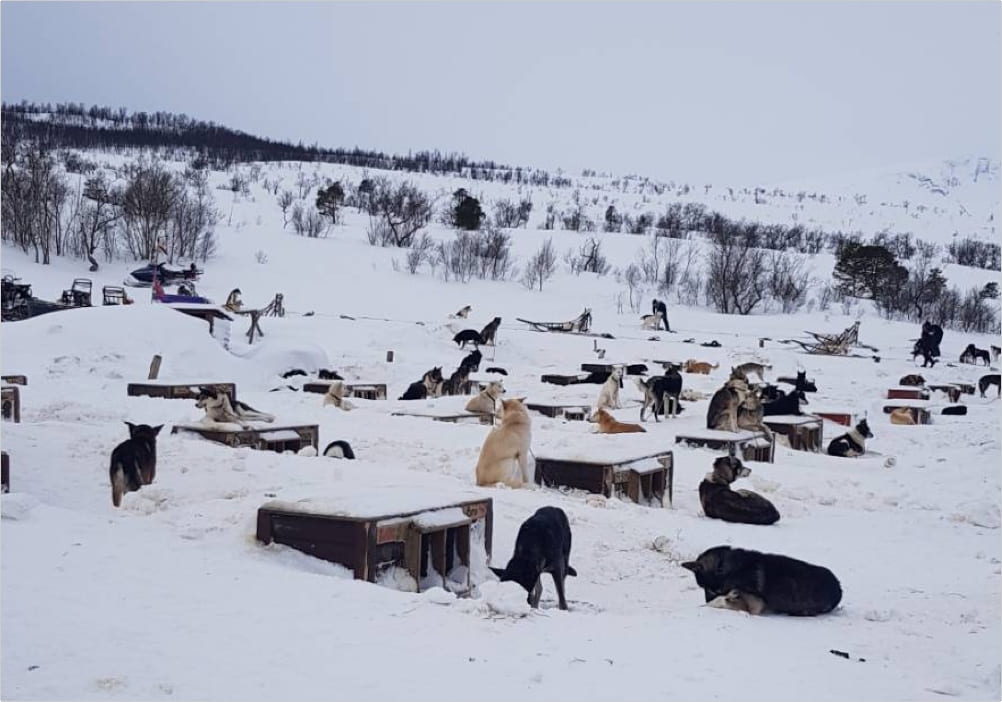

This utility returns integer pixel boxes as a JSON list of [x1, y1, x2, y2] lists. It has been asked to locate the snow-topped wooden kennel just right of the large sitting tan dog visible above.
[[535, 451, 675, 507]]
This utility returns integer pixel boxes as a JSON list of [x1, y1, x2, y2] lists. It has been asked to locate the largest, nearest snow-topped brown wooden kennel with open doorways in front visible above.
[[257, 498, 493, 594]]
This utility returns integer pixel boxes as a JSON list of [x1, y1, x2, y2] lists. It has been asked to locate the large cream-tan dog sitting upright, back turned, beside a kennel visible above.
[[477, 398, 532, 488]]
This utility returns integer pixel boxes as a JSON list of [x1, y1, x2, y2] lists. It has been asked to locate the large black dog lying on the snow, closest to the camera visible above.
[[681, 546, 842, 617]]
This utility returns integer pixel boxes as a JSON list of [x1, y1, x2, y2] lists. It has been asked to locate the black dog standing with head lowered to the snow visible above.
[[491, 507, 577, 610]]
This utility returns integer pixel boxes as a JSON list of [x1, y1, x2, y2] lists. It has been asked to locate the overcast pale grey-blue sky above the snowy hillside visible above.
[[0, 0, 1002, 183]]
